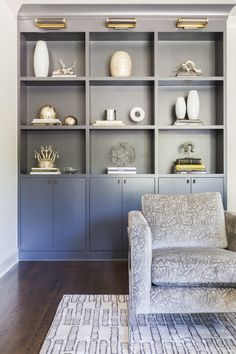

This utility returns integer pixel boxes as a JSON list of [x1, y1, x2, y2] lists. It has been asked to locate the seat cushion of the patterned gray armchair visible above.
[[151, 247, 236, 287]]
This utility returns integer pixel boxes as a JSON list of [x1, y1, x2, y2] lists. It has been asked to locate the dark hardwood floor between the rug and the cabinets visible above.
[[0, 261, 128, 354]]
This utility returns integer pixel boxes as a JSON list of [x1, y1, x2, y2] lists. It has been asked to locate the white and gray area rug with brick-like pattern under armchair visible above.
[[40, 295, 236, 354]]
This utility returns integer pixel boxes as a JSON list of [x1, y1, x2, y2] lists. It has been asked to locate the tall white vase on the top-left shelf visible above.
[[34, 41, 49, 77]]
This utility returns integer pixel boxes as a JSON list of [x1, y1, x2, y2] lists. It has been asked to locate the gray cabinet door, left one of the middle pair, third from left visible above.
[[90, 177, 122, 251]]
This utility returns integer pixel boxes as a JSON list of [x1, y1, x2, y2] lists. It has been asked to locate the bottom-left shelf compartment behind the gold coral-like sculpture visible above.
[[21, 130, 85, 173]]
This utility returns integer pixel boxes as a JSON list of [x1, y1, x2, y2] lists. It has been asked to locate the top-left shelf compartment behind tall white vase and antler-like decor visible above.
[[20, 32, 85, 77]]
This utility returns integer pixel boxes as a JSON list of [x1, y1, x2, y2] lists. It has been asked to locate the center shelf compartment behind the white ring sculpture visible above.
[[90, 81, 154, 126]]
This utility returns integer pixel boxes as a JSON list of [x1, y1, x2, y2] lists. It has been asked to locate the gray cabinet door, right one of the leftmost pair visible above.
[[53, 178, 85, 251]]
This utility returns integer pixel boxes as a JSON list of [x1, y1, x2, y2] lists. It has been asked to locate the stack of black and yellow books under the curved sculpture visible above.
[[173, 157, 206, 174]]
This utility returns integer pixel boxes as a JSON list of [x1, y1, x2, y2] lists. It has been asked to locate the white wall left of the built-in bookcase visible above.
[[0, 0, 17, 277]]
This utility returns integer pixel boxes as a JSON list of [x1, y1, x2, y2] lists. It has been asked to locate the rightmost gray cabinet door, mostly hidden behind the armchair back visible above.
[[192, 177, 224, 197]]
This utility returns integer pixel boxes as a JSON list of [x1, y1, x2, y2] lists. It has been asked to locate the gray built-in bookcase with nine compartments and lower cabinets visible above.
[[18, 5, 232, 259]]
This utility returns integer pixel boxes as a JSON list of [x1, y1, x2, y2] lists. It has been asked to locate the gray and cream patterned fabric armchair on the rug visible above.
[[128, 193, 236, 320]]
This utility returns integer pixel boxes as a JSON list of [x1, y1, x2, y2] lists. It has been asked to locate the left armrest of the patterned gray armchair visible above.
[[128, 211, 152, 314]]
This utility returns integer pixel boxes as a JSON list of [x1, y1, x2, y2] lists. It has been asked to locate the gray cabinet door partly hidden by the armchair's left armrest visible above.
[[122, 177, 155, 249]]
